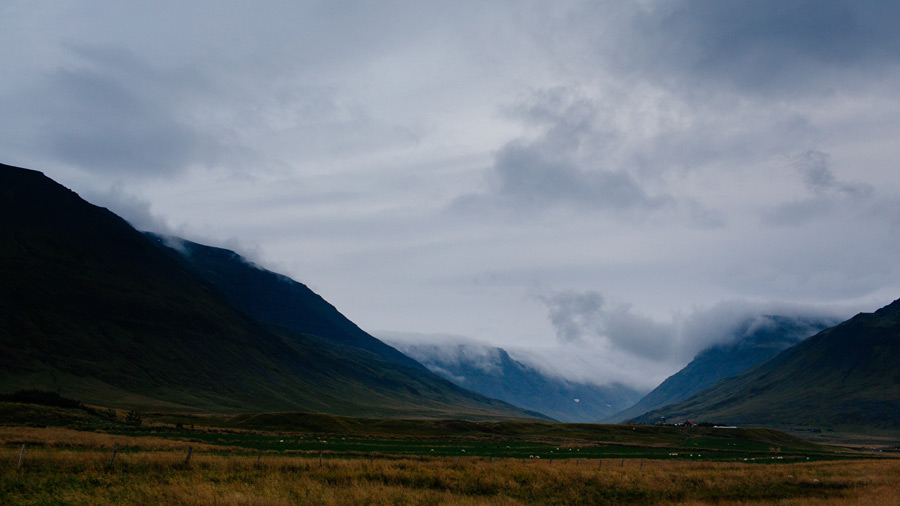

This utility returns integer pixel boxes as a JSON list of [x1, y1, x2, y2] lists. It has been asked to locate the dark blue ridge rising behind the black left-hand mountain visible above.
[[147, 234, 422, 368]]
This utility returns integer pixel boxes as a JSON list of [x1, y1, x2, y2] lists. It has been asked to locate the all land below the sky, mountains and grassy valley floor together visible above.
[[0, 166, 900, 505]]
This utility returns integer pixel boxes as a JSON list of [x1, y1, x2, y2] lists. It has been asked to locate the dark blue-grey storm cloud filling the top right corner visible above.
[[636, 0, 900, 93]]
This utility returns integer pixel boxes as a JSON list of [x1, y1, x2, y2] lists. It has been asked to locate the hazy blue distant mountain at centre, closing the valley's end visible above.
[[384, 342, 640, 422]]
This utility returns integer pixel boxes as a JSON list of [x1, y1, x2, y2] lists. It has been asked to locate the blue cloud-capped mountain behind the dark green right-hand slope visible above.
[[609, 315, 838, 422]]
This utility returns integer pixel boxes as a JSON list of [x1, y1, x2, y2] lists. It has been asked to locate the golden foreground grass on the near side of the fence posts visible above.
[[0, 448, 900, 506]]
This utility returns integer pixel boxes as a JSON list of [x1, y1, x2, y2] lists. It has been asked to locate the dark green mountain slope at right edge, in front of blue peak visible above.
[[638, 300, 900, 431]]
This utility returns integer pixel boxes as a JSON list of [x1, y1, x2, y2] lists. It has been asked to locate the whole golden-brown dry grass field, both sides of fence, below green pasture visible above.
[[0, 427, 900, 506]]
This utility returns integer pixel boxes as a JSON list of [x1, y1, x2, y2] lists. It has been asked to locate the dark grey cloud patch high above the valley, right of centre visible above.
[[455, 88, 674, 215]]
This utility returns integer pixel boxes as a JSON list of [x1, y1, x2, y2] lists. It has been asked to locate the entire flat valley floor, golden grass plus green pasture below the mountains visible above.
[[0, 410, 900, 506]]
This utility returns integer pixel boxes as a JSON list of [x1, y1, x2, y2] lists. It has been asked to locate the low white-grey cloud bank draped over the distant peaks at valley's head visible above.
[[377, 291, 849, 391]]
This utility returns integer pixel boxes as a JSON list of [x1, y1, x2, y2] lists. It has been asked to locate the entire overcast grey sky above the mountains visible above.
[[0, 0, 900, 388]]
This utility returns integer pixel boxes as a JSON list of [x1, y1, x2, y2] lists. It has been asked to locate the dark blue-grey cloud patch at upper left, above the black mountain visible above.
[[9, 45, 217, 176]]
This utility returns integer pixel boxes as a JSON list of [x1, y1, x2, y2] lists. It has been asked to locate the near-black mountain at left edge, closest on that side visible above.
[[0, 165, 534, 418]]
